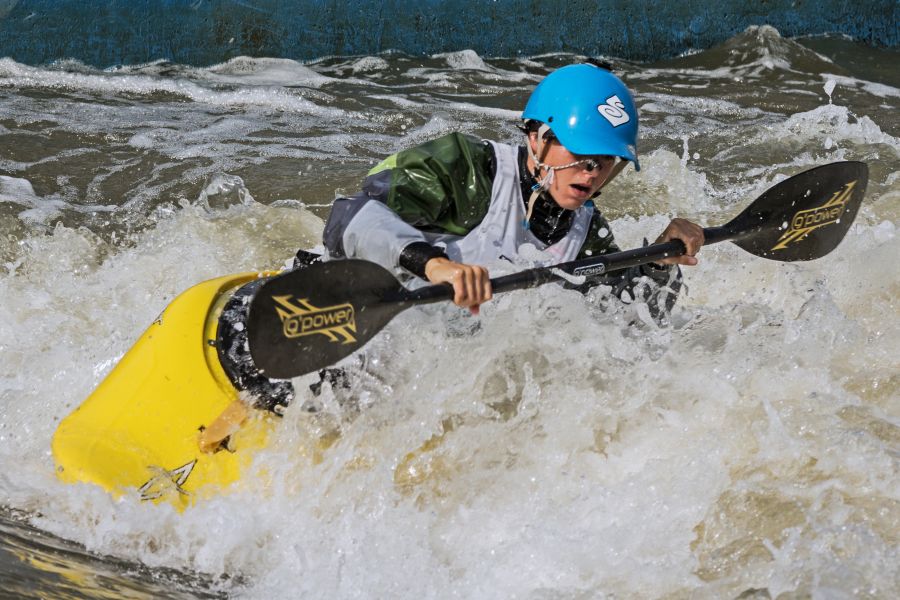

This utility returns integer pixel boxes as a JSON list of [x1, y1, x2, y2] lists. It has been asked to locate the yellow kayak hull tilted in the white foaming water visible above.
[[52, 273, 276, 510]]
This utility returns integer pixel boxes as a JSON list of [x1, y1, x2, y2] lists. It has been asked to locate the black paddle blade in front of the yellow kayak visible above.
[[247, 260, 408, 379]]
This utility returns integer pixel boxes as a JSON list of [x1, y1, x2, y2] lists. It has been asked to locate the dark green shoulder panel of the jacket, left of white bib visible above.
[[369, 133, 493, 235]]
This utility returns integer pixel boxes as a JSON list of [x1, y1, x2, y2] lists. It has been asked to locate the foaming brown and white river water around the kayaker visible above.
[[0, 28, 900, 599]]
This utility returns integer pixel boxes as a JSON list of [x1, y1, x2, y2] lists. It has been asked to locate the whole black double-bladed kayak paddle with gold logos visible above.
[[247, 162, 868, 379]]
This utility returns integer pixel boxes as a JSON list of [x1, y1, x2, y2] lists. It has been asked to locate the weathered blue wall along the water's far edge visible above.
[[0, 0, 900, 67]]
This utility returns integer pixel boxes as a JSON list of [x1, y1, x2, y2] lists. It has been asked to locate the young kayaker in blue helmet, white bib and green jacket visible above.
[[324, 64, 703, 314]]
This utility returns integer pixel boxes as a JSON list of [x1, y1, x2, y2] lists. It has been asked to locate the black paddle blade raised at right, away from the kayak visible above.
[[723, 162, 869, 262]]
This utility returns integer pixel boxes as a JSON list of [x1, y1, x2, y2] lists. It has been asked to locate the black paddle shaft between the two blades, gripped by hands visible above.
[[402, 225, 740, 304]]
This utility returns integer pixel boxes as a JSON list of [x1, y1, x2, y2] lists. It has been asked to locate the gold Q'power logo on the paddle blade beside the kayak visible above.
[[272, 296, 356, 344]]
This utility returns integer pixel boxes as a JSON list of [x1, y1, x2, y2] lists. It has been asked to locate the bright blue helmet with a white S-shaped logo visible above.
[[522, 64, 641, 171]]
